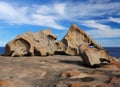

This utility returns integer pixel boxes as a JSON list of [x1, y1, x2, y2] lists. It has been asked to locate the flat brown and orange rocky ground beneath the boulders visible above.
[[0, 55, 120, 87]]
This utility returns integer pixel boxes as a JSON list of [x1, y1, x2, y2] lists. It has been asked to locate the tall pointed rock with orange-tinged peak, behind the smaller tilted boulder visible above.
[[60, 24, 103, 55]]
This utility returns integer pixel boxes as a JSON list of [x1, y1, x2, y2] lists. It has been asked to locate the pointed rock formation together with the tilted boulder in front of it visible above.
[[60, 24, 110, 66]]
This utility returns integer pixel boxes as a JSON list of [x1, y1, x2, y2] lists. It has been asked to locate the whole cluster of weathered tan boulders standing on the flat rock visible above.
[[5, 24, 110, 66]]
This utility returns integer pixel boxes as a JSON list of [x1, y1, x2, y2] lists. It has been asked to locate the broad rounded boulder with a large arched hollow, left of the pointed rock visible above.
[[5, 30, 57, 56]]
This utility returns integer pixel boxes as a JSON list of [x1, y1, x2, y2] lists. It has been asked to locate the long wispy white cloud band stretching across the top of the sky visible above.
[[0, 0, 120, 29]]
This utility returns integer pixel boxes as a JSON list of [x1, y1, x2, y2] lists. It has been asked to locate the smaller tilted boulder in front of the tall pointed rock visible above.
[[80, 47, 110, 66]]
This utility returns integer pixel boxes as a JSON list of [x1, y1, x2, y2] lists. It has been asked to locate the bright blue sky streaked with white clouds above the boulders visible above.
[[0, 0, 120, 47]]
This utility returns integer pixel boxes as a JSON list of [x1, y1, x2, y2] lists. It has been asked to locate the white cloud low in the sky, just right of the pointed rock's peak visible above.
[[83, 20, 120, 38]]
